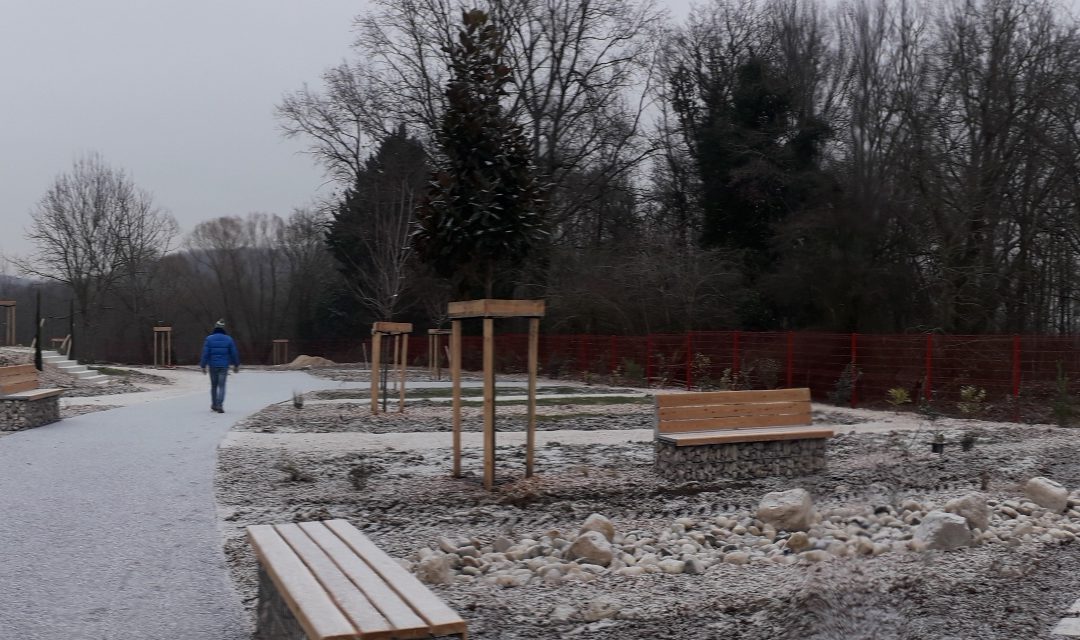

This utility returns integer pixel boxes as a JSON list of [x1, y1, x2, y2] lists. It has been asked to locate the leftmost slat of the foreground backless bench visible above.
[[247, 525, 356, 640]]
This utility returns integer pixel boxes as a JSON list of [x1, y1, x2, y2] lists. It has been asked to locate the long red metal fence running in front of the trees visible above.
[[261, 331, 1080, 406]]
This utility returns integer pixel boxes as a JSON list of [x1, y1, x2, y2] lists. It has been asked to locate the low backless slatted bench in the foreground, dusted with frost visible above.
[[247, 520, 467, 640]]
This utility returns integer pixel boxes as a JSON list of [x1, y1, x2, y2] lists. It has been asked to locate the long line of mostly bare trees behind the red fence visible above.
[[6, 0, 1080, 362]]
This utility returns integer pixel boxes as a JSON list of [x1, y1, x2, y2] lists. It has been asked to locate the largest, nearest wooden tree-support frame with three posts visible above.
[[447, 300, 544, 490]]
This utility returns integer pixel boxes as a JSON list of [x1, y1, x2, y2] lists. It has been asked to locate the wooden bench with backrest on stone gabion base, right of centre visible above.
[[654, 389, 833, 481]]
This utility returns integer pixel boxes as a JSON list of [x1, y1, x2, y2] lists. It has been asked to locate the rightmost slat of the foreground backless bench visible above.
[[324, 520, 465, 636]]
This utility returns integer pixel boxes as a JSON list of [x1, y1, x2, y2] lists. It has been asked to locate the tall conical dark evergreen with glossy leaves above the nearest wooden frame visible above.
[[414, 10, 546, 298]]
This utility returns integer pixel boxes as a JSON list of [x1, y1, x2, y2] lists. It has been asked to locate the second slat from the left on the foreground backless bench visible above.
[[274, 525, 394, 640]]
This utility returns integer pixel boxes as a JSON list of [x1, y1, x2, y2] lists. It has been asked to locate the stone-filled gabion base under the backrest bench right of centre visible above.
[[654, 438, 825, 481]]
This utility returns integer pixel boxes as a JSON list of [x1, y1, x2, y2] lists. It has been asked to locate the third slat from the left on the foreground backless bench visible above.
[[299, 522, 429, 638]]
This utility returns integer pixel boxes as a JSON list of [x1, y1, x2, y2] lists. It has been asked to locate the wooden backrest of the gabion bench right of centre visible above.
[[654, 389, 810, 433]]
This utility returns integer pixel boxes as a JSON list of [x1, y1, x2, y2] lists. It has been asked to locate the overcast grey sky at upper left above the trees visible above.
[[0, 0, 690, 263]]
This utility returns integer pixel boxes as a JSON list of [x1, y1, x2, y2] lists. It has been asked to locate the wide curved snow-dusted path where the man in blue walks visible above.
[[0, 371, 349, 640]]
